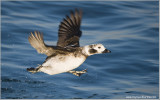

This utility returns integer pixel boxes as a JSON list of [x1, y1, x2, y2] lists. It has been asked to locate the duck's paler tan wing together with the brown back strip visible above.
[[28, 31, 77, 56]]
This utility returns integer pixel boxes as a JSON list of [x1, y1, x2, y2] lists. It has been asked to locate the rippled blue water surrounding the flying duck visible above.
[[1, 1, 159, 99]]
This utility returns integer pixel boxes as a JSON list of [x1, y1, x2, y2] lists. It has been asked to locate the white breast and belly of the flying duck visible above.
[[40, 54, 86, 75]]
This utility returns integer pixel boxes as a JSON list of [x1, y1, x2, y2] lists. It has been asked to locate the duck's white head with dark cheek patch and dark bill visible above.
[[82, 44, 111, 56]]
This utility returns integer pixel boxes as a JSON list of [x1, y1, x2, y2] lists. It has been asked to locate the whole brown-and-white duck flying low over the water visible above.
[[27, 9, 111, 76]]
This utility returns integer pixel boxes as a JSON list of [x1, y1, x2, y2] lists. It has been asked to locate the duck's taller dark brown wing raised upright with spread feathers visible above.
[[57, 9, 82, 47]]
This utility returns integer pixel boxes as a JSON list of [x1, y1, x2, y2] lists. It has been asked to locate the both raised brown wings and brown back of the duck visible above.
[[28, 9, 82, 56]]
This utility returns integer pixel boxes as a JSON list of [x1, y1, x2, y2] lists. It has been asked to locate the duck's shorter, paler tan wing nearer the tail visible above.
[[28, 32, 56, 56]]
